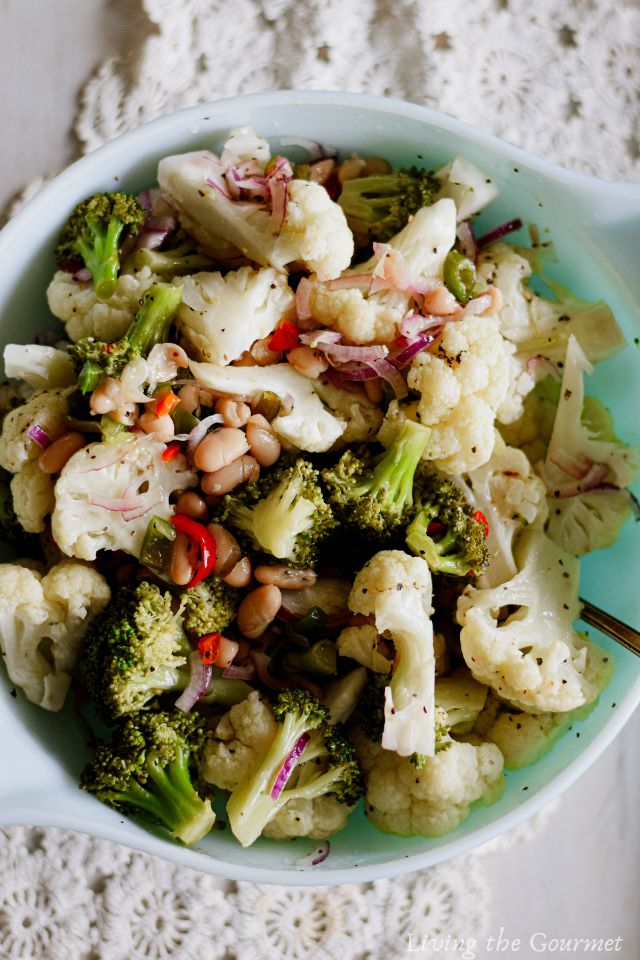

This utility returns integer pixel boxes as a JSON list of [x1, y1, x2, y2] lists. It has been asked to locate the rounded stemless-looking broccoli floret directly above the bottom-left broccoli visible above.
[[81, 580, 192, 720]]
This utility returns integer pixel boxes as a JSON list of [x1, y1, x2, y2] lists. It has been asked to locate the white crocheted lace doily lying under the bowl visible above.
[[0, 0, 640, 960]]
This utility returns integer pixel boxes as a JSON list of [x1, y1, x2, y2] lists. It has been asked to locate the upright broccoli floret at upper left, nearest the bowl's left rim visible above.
[[56, 193, 146, 300]]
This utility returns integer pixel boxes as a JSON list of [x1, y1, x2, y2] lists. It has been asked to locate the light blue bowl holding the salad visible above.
[[0, 92, 640, 885]]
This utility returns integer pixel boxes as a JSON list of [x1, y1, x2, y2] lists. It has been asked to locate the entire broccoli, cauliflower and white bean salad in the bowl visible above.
[[0, 127, 640, 864]]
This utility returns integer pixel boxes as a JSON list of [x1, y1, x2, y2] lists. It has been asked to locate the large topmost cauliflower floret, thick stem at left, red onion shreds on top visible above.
[[158, 150, 353, 280]]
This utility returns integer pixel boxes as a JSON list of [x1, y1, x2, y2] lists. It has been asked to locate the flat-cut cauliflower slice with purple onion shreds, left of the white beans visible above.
[[51, 436, 195, 560]]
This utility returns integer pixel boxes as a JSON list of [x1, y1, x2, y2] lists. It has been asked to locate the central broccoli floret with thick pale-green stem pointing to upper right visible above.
[[322, 420, 429, 539]]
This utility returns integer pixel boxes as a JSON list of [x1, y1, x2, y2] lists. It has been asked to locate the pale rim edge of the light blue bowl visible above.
[[0, 90, 640, 886]]
